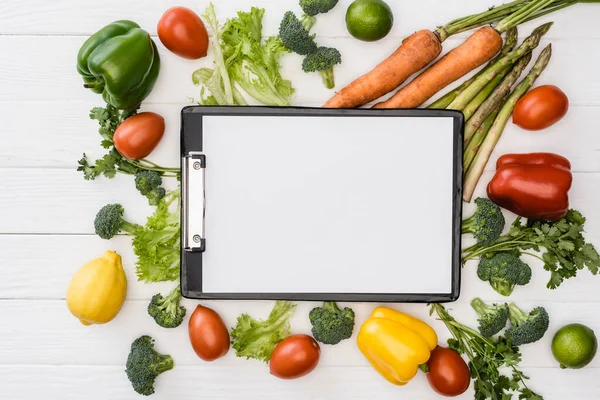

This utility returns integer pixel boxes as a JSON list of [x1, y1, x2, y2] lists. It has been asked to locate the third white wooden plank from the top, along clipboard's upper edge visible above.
[[0, 102, 600, 172]]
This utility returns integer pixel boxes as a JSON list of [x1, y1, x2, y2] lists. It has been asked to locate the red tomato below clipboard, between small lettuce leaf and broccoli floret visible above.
[[269, 335, 321, 379]]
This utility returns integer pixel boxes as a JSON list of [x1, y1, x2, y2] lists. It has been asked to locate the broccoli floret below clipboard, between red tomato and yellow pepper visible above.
[[308, 301, 354, 344]]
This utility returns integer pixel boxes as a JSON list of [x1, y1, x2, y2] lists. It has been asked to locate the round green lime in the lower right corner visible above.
[[552, 324, 598, 369]]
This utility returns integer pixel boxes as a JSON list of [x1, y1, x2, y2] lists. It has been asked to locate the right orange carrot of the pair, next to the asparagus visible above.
[[373, 26, 502, 108]]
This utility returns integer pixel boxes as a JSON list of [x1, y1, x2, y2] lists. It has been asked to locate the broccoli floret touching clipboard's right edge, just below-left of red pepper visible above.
[[462, 197, 506, 245]]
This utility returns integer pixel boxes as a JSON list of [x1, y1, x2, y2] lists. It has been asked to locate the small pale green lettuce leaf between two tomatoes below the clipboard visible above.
[[231, 301, 296, 362]]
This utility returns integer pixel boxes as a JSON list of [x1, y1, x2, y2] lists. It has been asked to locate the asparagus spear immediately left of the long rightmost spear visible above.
[[465, 53, 531, 143]]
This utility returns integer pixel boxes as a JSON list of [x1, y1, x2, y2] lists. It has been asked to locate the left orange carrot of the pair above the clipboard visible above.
[[323, 29, 442, 108]]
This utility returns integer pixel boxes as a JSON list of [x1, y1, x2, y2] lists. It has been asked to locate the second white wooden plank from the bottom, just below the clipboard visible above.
[[0, 297, 600, 371]]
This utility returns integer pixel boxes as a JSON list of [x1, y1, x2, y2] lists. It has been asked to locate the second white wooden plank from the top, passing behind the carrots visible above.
[[0, 36, 600, 104]]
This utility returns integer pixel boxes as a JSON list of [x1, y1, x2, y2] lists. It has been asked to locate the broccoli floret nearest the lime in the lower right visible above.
[[506, 303, 550, 346]]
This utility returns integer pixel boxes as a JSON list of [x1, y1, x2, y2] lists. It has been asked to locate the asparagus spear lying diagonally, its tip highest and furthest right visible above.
[[448, 22, 553, 110]]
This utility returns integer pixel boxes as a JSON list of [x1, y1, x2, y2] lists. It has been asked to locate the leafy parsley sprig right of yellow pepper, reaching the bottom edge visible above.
[[431, 304, 542, 400]]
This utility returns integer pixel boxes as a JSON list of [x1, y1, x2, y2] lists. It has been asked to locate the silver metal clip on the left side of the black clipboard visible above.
[[181, 152, 206, 251]]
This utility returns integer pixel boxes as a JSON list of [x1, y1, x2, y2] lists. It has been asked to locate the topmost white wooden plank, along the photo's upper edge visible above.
[[0, 0, 600, 38]]
